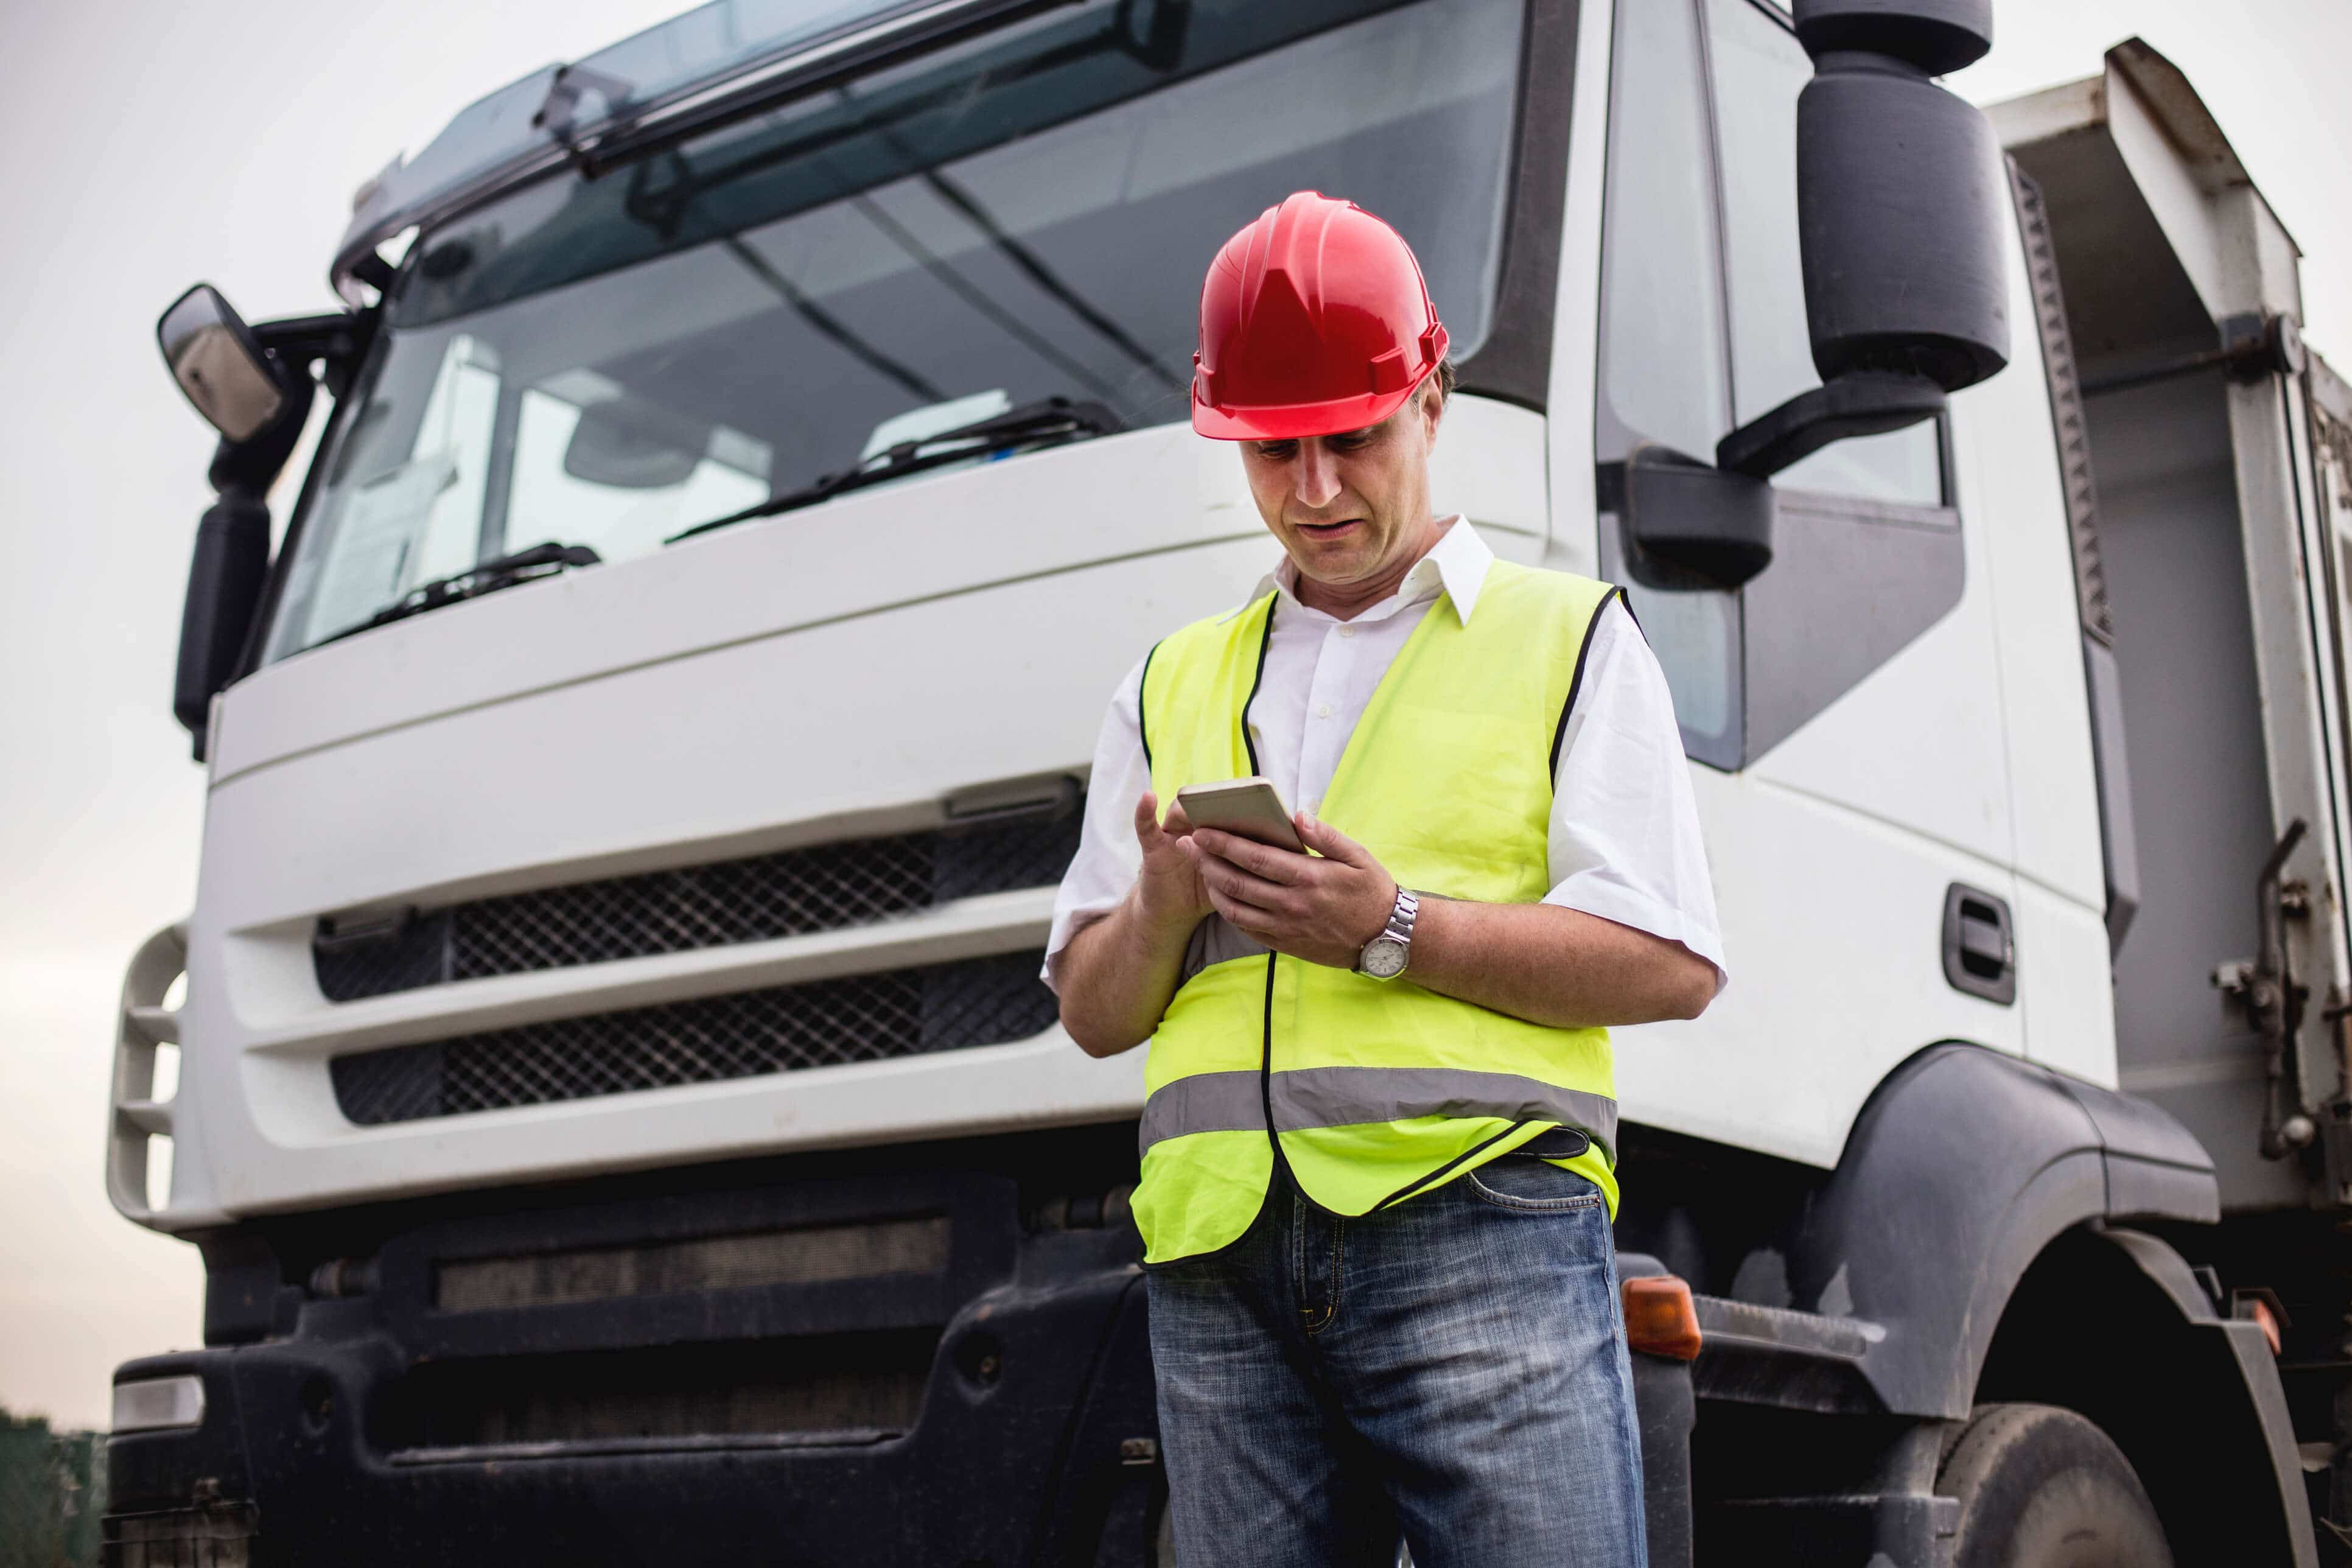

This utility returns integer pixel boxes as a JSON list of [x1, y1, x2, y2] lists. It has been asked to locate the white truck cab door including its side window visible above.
[[1590, 0, 2030, 1166]]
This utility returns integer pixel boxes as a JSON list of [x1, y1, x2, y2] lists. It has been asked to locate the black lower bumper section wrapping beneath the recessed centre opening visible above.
[[108, 1270, 1164, 1568]]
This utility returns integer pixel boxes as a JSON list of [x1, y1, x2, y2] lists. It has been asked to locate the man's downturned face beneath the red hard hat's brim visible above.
[[1239, 379, 1442, 588]]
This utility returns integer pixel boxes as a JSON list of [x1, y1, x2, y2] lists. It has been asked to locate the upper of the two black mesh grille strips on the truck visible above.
[[310, 804, 1082, 1001]]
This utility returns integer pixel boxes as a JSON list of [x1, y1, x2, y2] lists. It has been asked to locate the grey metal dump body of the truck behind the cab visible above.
[[1995, 40, 2352, 1208]]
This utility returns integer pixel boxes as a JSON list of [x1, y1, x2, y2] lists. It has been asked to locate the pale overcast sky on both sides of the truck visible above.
[[0, 0, 2352, 1424]]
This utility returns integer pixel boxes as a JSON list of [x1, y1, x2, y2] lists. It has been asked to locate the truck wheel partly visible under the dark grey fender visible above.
[[1936, 1404, 2173, 1568]]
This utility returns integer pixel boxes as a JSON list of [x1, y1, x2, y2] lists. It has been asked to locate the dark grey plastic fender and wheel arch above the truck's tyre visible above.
[[1788, 1041, 2317, 1566]]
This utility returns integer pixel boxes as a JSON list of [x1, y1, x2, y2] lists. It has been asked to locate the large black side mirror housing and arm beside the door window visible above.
[[1715, 0, 2009, 477]]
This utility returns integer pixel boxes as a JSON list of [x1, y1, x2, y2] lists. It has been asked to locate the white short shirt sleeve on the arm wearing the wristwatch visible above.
[[1543, 600, 1731, 992]]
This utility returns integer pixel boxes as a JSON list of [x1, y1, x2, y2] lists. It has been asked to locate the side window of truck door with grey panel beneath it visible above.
[[1592, 0, 1964, 769]]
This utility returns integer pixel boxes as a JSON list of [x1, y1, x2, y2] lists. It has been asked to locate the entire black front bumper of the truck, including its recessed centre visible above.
[[106, 1152, 1167, 1568]]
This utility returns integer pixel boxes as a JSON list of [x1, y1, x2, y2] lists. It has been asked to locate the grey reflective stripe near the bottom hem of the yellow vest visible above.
[[1138, 1067, 1616, 1152]]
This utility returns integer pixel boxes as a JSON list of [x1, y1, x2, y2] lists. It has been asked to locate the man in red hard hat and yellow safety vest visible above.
[[1046, 193, 1724, 1568]]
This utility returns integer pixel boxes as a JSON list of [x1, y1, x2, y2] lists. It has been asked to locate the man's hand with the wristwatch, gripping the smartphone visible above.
[[1171, 778, 1397, 968]]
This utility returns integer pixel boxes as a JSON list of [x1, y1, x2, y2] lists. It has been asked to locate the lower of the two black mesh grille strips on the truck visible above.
[[329, 950, 1056, 1126]]
